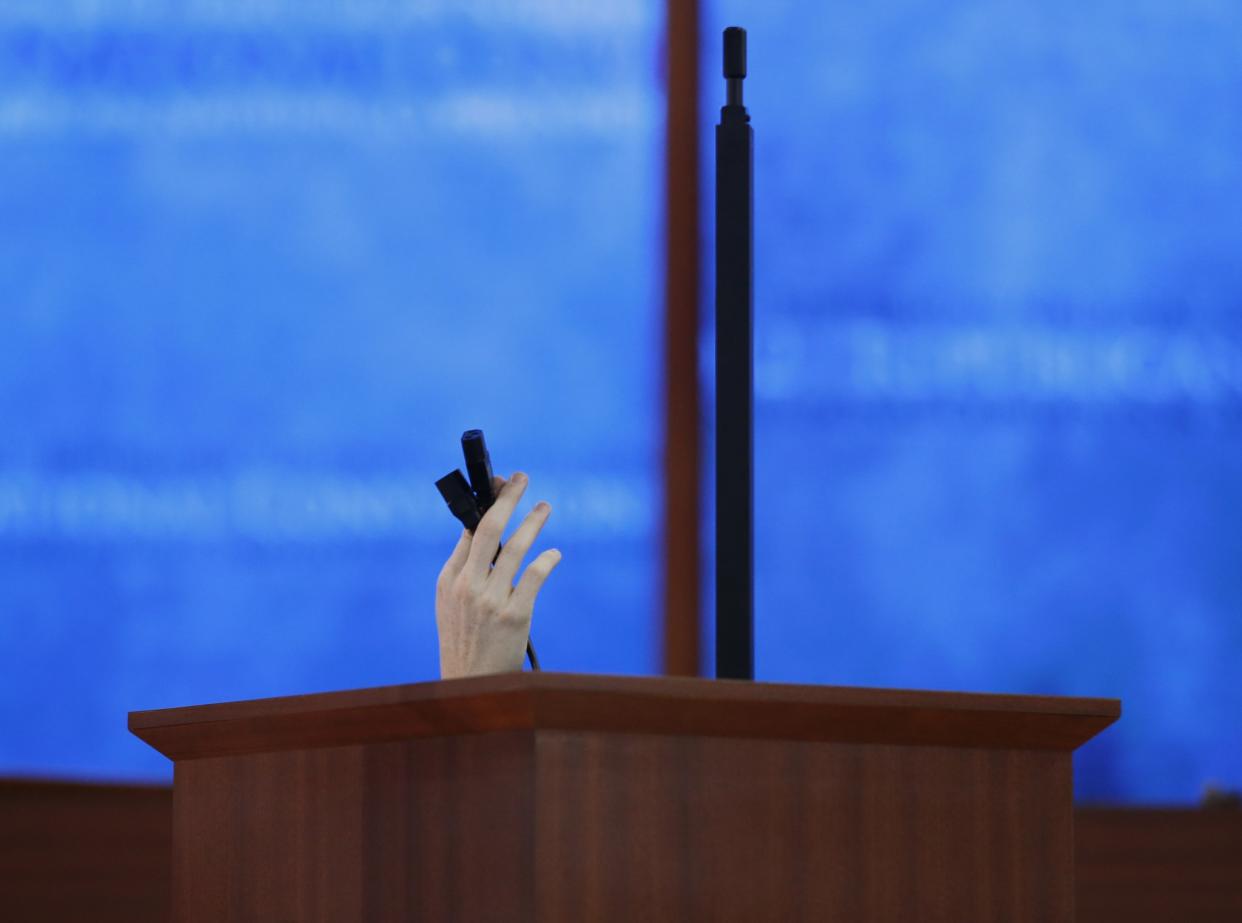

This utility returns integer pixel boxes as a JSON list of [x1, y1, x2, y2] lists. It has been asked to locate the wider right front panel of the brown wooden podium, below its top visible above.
[[535, 732, 1073, 923]]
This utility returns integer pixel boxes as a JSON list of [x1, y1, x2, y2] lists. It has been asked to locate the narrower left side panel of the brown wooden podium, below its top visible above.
[[173, 733, 534, 923]]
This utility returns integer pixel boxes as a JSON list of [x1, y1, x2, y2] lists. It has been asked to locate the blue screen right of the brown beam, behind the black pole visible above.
[[703, 0, 1242, 801]]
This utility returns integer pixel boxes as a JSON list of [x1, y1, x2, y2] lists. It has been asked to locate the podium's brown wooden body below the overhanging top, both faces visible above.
[[162, 732, 1073, 923]]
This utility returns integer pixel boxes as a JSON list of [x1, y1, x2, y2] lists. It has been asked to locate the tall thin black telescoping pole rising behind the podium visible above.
[[715, 26, 755, 680]]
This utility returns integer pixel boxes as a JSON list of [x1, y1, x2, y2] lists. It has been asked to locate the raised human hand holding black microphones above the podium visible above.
[[436, 472, 560, 680]]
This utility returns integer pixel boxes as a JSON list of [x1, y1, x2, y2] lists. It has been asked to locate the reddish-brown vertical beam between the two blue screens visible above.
[[663, 0, 702, 676]]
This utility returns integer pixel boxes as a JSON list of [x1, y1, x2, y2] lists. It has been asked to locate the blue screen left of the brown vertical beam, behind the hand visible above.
[[0, 0, 663, 778]]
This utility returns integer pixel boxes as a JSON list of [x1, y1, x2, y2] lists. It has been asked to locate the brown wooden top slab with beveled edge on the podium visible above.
[[129, 672, 1122, 760]]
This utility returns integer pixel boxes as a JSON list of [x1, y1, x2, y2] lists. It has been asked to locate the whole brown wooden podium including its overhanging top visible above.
[[129, 673, 1120, 923]]
